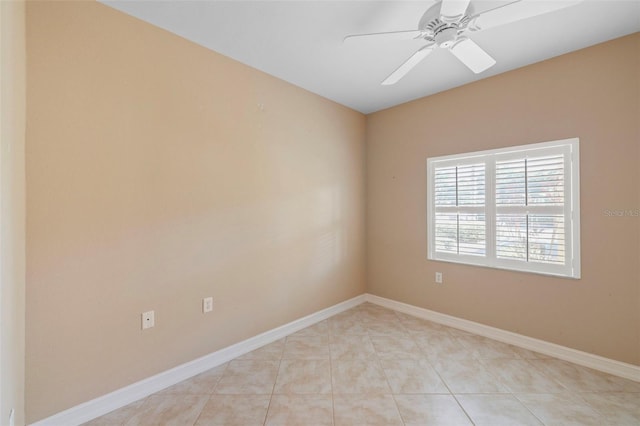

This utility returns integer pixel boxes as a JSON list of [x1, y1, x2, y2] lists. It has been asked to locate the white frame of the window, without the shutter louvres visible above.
[[427, 138, 581, 279]]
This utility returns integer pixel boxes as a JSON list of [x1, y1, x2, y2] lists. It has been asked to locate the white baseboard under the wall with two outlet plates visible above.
[[32, 294, 365, 426]]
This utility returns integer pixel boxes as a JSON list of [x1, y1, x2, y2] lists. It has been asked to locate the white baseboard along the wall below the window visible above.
[[365, 294, 640, 382]]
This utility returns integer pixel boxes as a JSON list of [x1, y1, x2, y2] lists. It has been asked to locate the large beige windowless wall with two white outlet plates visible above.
[[26, 2, 365, 422]]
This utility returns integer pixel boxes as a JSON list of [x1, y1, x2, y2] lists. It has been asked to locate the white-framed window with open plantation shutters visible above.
[[427, 138, 580, 278]]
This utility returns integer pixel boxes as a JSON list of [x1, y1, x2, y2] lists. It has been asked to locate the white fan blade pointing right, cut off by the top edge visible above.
[[473, 0, 583, 30]]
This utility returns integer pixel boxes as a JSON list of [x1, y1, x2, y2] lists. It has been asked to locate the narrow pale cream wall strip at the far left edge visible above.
[[0, 1, 26, 425]]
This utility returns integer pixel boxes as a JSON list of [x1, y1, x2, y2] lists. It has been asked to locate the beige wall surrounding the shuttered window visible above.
[[366, 33, 640, 365]]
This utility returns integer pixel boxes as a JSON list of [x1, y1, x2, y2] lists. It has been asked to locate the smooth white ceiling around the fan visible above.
[[102, 0, 640, 113]]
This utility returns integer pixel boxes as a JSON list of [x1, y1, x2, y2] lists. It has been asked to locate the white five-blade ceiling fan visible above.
[[344, 0, 583, 85]]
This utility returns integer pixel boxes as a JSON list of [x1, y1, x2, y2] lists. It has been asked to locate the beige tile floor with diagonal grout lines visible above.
[[86, 303, 640, 426]]
